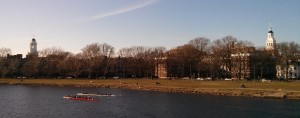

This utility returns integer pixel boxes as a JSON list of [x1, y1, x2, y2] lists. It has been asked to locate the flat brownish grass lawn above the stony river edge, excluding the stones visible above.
[[0, 79, 300, 91]]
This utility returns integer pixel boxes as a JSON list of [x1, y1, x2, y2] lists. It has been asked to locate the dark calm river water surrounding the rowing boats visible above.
[[0, 85, 300, 118]]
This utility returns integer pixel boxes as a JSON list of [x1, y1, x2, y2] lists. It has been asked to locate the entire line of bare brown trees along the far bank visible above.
[[0, 36, 300, 79]]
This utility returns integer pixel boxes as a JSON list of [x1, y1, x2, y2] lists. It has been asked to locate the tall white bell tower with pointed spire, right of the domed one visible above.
[[266, 22, 276, 50]]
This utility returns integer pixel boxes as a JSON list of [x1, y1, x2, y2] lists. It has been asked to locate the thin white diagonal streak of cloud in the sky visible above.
[[87, 0, 158, 21]]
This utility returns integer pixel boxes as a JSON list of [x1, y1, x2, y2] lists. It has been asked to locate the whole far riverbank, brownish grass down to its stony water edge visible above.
[[0, 79, 300, 99]]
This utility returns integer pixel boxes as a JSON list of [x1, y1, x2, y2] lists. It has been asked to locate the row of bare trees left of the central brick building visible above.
[[0, 43, 166, 78]]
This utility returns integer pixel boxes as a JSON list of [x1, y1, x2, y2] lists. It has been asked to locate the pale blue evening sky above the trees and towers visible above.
[[0, 0, 300, 56]]
